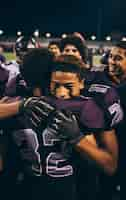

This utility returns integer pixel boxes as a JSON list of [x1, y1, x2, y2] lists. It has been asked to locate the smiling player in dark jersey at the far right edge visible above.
[[108, 41, 126, 200]]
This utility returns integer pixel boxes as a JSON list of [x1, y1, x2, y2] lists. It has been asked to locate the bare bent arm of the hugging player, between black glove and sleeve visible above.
[[75, 130, 118, 175]]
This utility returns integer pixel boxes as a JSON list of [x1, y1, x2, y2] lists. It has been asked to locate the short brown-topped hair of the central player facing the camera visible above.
[[52, 55, 85, 80]]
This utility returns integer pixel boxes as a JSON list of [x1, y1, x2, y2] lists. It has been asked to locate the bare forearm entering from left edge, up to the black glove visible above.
[[0, 101, 20, 119]]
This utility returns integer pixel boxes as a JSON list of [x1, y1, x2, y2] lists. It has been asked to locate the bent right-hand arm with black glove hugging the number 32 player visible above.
[[49, 111, 118, 175]]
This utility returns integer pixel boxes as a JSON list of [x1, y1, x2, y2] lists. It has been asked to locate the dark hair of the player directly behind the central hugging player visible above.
[[60, 35, 88, 63]]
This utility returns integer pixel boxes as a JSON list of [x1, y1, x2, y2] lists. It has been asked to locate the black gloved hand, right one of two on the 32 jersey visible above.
[[48, 111, 84, 144]]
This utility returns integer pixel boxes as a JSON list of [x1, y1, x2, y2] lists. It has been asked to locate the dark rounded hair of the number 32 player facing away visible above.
[[21, 48, 53, 89]]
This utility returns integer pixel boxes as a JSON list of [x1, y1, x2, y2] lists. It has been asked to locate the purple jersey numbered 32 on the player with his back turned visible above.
[[1, 97, 106, 178]]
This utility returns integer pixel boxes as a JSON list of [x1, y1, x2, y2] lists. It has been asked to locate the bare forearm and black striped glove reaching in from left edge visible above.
[[0, 97, 55, 130]]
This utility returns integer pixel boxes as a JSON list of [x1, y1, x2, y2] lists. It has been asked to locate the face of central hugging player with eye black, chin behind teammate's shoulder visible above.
[[50, 71, 84, 99]]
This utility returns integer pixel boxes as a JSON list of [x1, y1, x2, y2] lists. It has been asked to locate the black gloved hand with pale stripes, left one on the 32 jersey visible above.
[[19, 97, 55, 131]]
